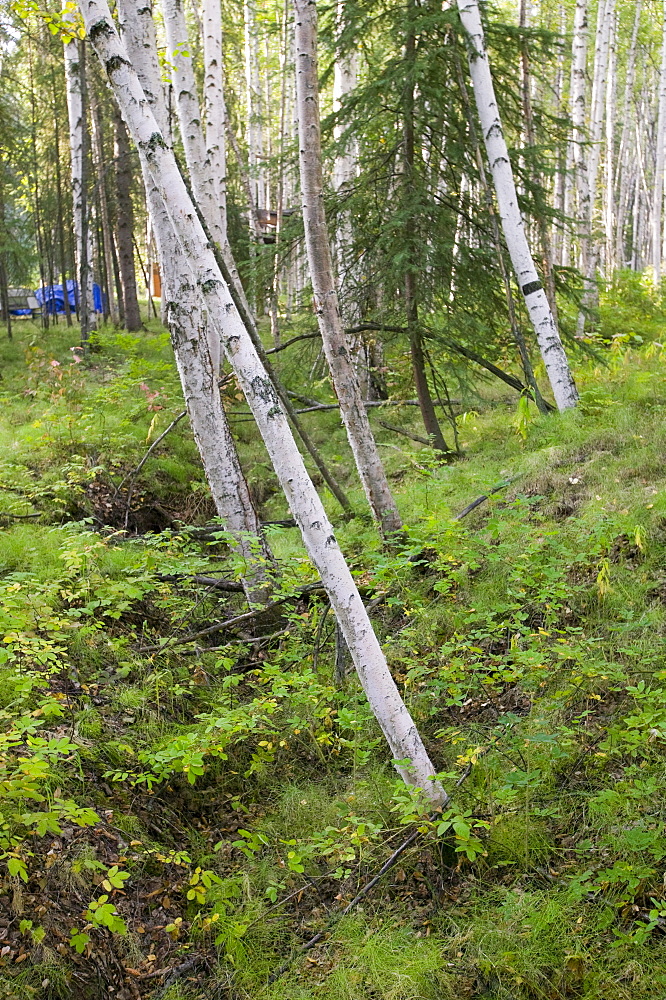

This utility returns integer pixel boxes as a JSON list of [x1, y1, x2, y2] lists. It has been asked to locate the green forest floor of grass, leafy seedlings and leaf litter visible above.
[[0, 284, 666, 1000]]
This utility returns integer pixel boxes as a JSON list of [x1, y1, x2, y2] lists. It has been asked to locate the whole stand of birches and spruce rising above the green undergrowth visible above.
[[0, 0, 666, 808]]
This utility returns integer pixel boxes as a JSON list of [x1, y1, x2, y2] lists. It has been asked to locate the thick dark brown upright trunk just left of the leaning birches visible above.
[[113, 111, 142, 330]]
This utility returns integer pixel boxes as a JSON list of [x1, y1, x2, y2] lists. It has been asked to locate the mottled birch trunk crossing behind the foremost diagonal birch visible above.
[[119, 0, 272, 602]]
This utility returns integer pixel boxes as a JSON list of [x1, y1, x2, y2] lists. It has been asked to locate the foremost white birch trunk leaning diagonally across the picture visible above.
[[81, 0, 448, 808]]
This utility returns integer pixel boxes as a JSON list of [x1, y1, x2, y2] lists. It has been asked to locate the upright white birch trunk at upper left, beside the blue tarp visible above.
[[63, 16, 95, 343]]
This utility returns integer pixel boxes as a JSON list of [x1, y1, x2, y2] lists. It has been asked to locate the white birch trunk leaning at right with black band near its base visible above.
[[458, 0, 578, 410]]
